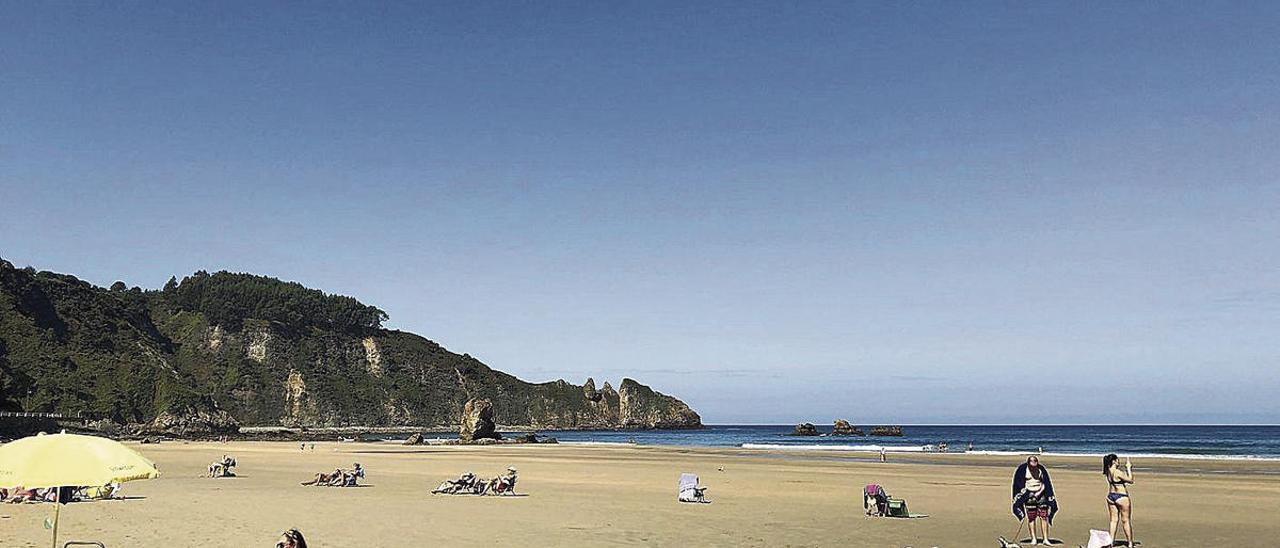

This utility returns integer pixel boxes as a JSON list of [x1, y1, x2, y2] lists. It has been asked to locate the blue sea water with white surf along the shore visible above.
[[522, 425, 1280, 460]]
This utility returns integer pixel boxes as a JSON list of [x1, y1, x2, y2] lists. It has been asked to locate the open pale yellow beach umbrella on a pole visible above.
[[0, 434, 160, 548]]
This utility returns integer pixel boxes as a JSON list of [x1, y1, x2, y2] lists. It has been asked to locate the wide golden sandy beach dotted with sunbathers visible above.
[[0, 442, 1280, 548]]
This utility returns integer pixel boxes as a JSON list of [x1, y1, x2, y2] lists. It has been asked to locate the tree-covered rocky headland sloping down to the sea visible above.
[[0, 261, 701, 433]]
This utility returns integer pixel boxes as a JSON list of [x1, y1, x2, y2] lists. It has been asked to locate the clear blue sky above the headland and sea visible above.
[[0, 1, 1280, 424]]
